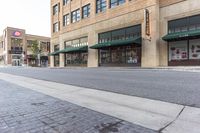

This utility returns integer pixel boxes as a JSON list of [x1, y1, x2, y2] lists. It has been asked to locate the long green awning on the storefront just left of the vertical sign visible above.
[[90, 37, 142, 49]]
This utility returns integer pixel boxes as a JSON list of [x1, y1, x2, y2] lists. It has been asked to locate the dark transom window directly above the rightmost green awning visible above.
[[168, 15, 200, 34]]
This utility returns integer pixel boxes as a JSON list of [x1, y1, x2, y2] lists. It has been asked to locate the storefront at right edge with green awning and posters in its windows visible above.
[[163, 15, 200, 66]]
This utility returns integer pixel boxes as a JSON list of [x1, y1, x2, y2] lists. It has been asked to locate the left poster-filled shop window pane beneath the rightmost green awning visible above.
[[169, 41, 188, 61]]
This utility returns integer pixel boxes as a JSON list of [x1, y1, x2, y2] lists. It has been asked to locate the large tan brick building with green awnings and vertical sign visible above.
[[51, 0, 200, 67]]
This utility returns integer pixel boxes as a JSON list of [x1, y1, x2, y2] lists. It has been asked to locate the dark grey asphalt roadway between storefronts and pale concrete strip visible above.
[[0, 67, 200, 107]]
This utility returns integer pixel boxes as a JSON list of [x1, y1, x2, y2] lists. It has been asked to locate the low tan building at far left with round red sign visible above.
[[0, 27, 50, 67]]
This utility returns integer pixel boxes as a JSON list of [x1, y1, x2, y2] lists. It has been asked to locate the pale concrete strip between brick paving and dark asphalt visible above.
[[0, 73, 200, 133]]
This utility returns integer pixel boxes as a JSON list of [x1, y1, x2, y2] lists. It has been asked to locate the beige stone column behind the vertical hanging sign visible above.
[[142, 2, 159, 67]]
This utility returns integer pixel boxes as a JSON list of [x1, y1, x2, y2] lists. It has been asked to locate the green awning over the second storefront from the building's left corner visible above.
[[59, 46, 88, 53]]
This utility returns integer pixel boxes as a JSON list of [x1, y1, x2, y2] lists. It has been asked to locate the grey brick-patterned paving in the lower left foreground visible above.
[[0, 80, 156, 133]]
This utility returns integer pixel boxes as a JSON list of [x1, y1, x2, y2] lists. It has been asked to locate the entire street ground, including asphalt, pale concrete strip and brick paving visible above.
[[0, 67, 200, 133]]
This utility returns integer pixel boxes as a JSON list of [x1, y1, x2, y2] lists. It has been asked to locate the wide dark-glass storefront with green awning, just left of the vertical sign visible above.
[[90, 25, 141, 66]]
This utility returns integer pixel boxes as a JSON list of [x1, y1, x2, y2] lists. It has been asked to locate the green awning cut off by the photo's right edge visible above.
[[162, 30, 200, 41]]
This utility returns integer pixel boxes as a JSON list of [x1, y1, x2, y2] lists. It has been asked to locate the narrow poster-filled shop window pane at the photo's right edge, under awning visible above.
[[189, 39, 200, 59]]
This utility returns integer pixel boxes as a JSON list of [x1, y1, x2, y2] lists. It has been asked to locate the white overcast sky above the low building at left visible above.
[[0, 0, 51, 37]]
